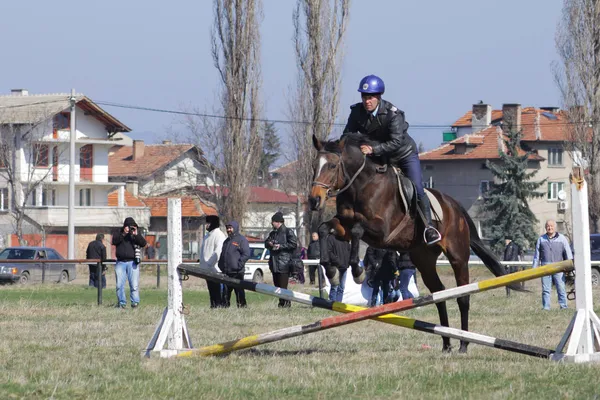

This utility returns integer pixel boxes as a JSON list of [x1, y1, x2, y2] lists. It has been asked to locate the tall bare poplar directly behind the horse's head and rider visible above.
[[288, 0, 350, 238]]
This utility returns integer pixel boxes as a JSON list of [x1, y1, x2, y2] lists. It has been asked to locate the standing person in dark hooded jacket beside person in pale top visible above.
[[219, 221, 250, 308]]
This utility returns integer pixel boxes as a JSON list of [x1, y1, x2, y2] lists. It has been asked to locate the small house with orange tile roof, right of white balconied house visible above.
[[108, 140, 213, 197]]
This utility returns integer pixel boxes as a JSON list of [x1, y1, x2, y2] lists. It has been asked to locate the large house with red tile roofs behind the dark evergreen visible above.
[[419, 103, 573, 237]]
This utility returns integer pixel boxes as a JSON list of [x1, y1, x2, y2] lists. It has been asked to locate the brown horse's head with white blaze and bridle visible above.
[[308, 135, 344, 211]]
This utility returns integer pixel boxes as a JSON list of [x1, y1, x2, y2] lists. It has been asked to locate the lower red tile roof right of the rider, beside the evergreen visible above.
[[419, 126, 544, 161]]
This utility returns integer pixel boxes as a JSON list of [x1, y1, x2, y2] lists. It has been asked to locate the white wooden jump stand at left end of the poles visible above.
[[145, 198, 192, 357]]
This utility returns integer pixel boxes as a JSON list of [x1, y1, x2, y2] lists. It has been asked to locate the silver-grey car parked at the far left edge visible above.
[[0, 247, 77, 283]]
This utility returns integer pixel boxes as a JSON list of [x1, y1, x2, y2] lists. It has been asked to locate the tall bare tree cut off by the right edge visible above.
[[554, 0, 600, 232]]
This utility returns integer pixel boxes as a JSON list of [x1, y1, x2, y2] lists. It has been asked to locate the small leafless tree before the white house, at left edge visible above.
[[0, 107, 61, 245]]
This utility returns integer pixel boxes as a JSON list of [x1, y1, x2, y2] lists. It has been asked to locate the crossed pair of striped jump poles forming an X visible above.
[[178, 260, 573, 358]]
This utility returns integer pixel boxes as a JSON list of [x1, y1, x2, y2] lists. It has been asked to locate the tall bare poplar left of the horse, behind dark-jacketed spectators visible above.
[[211, 0, 262, 221]]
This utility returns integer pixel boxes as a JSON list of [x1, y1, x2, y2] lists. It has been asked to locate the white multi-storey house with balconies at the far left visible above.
[[0, 90, 150, 258]]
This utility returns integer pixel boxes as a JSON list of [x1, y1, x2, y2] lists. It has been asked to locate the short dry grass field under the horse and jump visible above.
[[0, 267, 600, 400]]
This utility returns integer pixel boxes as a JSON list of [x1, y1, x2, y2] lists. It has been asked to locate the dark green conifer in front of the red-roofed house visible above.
[[483, 126, 546, 252]]
